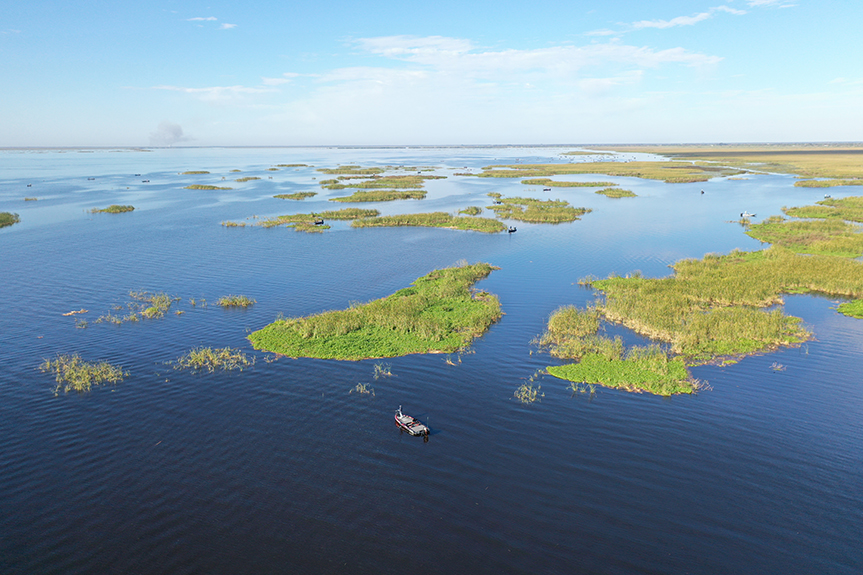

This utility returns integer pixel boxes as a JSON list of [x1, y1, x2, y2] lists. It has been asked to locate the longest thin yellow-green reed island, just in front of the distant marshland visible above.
[[477, 162, 744, 183]]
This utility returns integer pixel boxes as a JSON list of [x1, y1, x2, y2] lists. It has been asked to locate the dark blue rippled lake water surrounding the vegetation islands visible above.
[[0, 148, 863, 575]]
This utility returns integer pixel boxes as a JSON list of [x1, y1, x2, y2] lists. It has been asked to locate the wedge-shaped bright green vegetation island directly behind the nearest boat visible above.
[[249, 263, 501, 360]]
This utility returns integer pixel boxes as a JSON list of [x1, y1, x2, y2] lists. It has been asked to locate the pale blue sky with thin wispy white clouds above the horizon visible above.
[[0, 0, 863, 147]]
